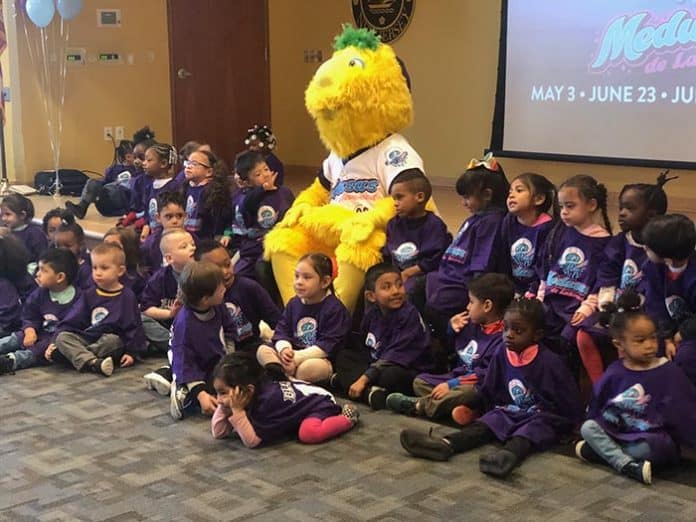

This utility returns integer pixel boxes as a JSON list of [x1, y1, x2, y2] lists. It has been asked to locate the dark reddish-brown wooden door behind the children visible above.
[[168, 0, 271, 166]]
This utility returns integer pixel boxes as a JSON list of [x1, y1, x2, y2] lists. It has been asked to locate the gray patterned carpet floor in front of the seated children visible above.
[[0, 360, 696, 522]]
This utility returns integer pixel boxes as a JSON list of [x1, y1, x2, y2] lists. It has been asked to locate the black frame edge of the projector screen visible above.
[[485, 0, 696, 170]]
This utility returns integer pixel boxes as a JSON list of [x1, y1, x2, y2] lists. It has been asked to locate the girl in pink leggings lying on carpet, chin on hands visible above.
[[212, 353, 358, 448]]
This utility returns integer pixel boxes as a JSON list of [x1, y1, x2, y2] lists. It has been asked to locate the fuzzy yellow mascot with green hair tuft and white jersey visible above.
[[265, 26, 423, 311]]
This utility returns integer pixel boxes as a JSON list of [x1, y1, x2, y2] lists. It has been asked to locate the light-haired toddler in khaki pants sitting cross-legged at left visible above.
[[46, 243, 146, 377]]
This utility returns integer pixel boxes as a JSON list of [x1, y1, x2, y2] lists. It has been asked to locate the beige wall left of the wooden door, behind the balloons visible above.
[[6, 0, 172, 182]]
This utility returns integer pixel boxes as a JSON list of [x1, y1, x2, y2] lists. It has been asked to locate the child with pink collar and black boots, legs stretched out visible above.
[[401, 299, 582, 477]]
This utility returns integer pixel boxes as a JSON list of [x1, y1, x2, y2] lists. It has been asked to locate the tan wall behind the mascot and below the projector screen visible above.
[[269, 0, 696, 210]]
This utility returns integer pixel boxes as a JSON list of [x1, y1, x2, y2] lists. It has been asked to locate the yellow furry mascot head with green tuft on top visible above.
[[305, 25, 413, 158]]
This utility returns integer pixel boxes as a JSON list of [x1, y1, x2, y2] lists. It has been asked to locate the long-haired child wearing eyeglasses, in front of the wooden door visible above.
[[184, 149, 232, 239]]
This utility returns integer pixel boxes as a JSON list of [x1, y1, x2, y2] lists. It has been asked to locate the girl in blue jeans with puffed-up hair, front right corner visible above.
[[575, 291, 696, 484]]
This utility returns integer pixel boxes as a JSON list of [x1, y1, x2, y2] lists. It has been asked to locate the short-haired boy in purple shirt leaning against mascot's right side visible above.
[[382, 169, 452, 313]]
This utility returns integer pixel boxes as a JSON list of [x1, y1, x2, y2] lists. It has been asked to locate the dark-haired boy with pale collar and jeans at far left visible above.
[[0, 248, 78, 375]]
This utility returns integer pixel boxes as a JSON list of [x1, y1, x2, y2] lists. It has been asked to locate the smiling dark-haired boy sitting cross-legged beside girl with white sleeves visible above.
[[332, 263, 433, 410]]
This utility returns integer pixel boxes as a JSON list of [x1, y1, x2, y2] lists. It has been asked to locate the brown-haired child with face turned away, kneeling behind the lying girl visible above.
[[169, 261, 235, 420]]
